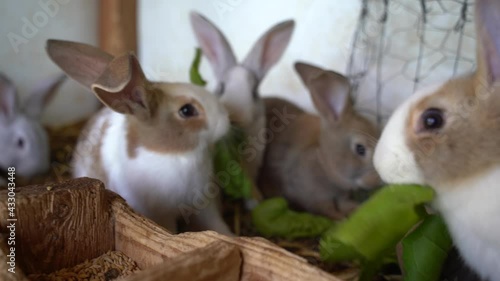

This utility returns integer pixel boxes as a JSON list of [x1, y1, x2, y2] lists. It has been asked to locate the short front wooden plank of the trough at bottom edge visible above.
[[123, 241, 241, 281]]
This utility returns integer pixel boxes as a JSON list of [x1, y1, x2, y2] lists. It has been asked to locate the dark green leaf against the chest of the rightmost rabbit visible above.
[[402, 215, 453, 281]]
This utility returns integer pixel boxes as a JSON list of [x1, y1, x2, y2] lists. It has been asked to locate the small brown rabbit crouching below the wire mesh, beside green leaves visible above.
[[259, 63, 381, 219]]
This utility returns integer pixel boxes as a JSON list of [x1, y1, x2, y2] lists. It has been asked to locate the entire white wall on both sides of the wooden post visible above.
[[0, 0, 475, 125]]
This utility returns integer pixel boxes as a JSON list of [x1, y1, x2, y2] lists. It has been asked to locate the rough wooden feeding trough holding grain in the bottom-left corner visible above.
[[0, 178, 338, 281]]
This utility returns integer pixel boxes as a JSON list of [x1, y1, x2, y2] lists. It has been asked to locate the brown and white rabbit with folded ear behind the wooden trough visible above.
[[47, 40, 230, 234]]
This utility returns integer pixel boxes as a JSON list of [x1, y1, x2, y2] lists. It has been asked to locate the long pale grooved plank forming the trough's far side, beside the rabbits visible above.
[[112, 197, 339, 281]]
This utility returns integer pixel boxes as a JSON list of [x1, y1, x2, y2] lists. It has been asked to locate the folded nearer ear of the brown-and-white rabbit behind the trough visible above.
[[91, 54, 153, 119]]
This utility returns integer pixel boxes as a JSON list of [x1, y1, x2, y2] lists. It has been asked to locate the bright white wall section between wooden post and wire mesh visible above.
[[139, 0, 360, 112]]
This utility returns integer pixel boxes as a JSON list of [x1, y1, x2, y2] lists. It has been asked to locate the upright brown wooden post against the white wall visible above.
[[99, 0, 137, 55]]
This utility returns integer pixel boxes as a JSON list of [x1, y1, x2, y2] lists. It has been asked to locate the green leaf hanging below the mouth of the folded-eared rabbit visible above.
[[214, 129, 253, 199]]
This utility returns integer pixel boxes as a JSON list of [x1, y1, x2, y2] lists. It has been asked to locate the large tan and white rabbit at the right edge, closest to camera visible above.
[[374, 0, 500, 280]]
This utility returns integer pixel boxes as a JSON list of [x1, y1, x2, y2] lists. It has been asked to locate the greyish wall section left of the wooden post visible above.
[[0, 0, 98, 125]]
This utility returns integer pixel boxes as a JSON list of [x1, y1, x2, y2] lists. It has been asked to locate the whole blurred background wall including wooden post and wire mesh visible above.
[[0, 0, 475, 126]]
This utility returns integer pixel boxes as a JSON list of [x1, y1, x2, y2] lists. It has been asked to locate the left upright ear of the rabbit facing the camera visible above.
[[190, 12, 236, 80]]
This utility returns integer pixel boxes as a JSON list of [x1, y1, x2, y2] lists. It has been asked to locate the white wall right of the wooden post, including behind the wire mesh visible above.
[[139, 0, 475, 122]]
